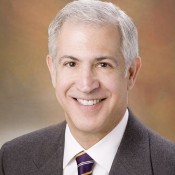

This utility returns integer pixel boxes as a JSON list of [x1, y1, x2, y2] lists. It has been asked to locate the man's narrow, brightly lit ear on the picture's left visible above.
[[46, 55, 56, 88]]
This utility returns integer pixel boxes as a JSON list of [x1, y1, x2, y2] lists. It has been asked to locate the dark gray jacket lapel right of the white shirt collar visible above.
[[109, 112, 152, 175]]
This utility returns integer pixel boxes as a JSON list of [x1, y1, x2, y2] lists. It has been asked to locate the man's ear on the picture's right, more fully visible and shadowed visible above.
[[128, 57, 142, 90]]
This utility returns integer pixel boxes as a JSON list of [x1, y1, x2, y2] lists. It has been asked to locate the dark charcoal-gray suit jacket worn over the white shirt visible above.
[[0, 112, 175, 175]]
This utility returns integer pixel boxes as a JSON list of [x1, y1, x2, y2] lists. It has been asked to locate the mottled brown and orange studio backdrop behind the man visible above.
[[0, 0, 175, 146]]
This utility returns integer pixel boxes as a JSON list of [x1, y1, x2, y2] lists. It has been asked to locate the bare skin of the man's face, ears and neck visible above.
[[47, 22, 141, 149]]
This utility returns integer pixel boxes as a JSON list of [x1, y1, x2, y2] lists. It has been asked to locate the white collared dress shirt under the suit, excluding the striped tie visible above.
[[63, 110, 128, 175]]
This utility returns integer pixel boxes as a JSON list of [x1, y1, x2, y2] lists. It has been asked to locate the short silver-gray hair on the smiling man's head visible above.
[[48, 0, 138, 70]]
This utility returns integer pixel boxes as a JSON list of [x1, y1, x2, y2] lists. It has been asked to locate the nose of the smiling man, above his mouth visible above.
[[77, 68, 100, 94]]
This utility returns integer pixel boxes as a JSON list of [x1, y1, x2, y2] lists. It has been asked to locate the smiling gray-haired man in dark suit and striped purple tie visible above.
[[0, 0, 175, 175]]
